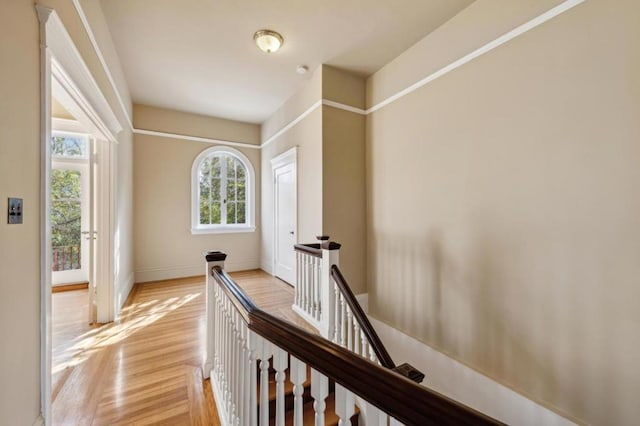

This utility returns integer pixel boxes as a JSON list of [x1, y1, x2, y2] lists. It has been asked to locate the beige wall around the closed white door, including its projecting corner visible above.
[[262, 65, 366, 293]]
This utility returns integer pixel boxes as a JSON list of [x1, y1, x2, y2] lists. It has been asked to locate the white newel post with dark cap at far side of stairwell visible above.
[[317, 235, 340, 340]]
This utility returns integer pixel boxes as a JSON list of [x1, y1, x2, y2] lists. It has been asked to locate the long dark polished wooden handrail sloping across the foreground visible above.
[[211, 266, 501, 425]]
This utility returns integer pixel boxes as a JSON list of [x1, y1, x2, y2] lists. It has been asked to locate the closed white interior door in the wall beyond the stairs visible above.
[[273, 151, 297, 286]]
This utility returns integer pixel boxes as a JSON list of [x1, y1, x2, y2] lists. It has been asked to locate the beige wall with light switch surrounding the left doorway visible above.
[[0, 0, 131, 425]]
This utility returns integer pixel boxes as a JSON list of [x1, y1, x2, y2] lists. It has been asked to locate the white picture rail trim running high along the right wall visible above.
[[366, 0, 586, 115]]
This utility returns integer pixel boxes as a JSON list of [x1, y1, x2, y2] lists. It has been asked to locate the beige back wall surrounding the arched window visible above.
[[133, 105, 260, 282]]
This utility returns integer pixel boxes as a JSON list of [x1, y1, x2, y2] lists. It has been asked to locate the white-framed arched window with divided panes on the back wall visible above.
[[191, 146, 255, 234]]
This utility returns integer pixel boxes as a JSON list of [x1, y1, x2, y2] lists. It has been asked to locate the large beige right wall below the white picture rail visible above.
[[366, 0, 640, 425]]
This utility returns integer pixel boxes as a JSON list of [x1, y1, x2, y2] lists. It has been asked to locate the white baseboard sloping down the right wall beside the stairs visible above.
[[368, 316, 575, 426]]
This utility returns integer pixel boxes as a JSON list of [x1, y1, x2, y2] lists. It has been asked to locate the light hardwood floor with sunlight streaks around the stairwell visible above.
[[52, 271, 306, 425]]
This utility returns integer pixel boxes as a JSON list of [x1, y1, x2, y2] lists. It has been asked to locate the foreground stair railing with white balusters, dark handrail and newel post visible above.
[[204, 252, 498, 426]]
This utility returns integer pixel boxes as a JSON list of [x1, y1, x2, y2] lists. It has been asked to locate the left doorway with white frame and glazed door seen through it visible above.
[[36, 5, 122, 425]]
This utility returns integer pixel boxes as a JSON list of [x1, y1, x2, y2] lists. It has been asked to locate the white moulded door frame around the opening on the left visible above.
[[35, 4, 122, 425]]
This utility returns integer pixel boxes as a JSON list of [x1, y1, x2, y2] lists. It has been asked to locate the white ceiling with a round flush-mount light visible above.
[[101, 0, 473, 123]]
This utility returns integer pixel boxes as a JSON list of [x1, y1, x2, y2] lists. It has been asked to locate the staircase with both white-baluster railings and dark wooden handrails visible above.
[[203, 245, 499, 426]]
